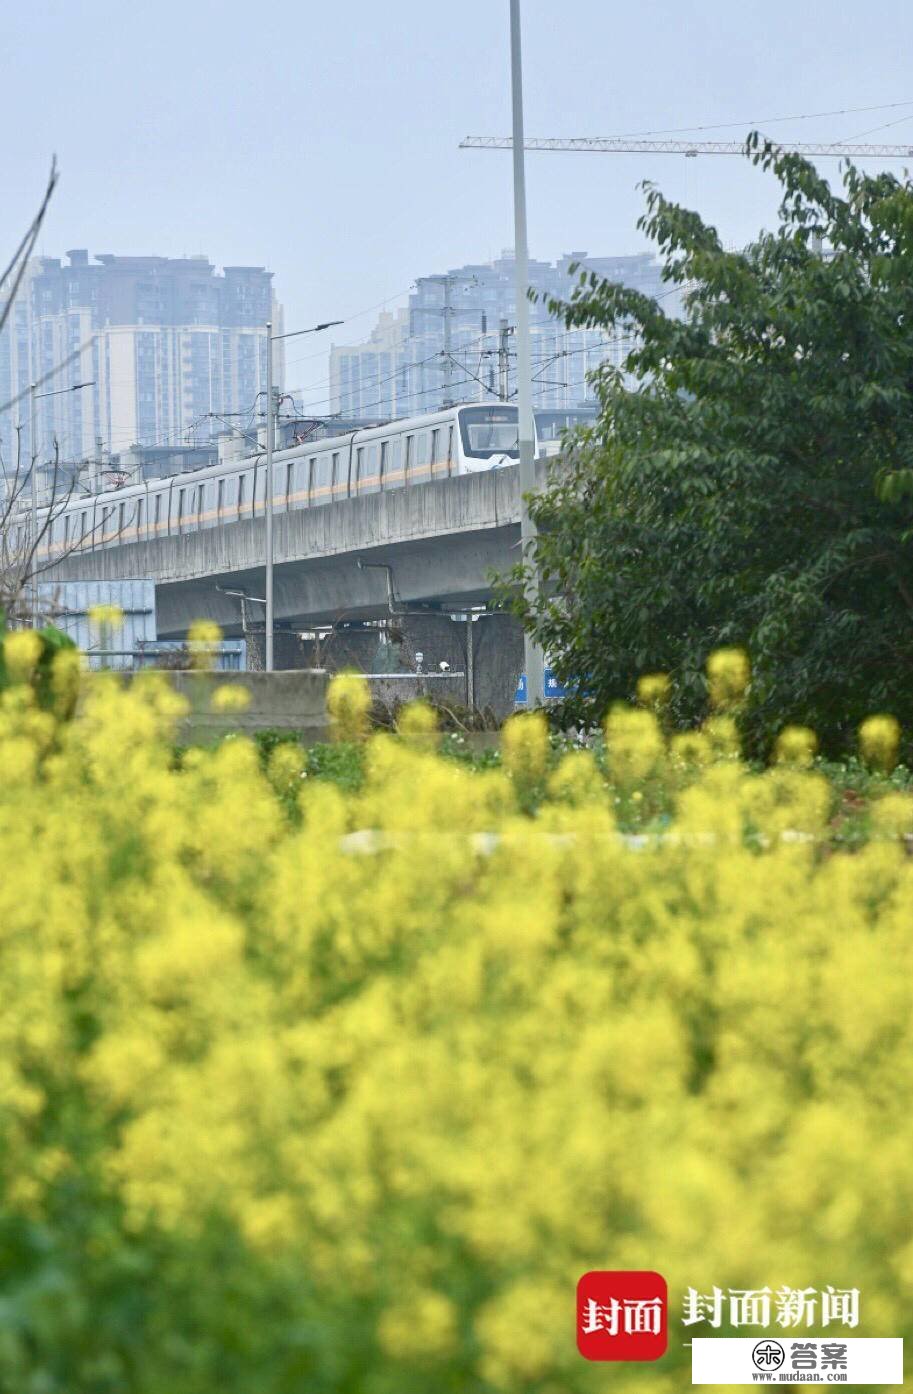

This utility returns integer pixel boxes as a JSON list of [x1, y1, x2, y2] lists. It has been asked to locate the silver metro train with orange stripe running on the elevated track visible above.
[[28, 404, 594, 555]]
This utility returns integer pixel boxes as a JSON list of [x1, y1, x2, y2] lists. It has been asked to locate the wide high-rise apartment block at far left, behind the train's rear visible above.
[[0, 250, 282, 479]]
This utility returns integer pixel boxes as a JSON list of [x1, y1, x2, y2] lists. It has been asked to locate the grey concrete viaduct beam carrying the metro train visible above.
[[49, 464, 544, 638]]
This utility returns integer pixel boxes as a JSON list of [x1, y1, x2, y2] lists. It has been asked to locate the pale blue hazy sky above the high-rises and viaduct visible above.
[[7, 0, 913, 410]]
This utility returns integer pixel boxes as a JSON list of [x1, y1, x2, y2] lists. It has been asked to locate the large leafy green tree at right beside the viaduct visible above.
[[505, 134, 913, 749]]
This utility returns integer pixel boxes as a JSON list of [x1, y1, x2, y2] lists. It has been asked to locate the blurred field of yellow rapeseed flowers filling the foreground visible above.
[[0, 657, 913, 1394]]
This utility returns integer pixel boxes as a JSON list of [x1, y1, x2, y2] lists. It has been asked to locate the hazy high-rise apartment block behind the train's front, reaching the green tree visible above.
[[330, 252, 679, 417]]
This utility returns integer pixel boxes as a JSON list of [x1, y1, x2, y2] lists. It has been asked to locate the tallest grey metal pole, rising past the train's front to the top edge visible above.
[[510, 0, 545, 711]]
